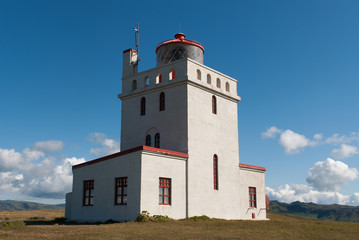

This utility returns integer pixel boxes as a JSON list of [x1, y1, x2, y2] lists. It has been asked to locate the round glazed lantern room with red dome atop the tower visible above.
[[156, 33, 204, 67]]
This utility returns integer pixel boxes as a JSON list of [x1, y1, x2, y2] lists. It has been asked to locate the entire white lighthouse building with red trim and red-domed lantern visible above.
[[66, 33, 266, 221]]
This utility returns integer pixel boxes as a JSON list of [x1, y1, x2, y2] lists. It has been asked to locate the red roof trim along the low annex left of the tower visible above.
[[72, 146, 188, 169]]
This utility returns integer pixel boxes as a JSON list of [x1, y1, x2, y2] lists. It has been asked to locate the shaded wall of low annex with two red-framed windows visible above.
[[71, 151, 141, 222]]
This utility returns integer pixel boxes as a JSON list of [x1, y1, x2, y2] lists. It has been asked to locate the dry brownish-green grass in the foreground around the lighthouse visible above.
[[0, 210, 359, 240]]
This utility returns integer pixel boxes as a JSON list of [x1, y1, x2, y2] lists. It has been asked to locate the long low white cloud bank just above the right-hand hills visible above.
[[266, 184, 359, 206]]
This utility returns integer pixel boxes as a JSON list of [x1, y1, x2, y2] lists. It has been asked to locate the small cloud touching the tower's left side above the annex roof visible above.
[[89, 133, 121, 156]]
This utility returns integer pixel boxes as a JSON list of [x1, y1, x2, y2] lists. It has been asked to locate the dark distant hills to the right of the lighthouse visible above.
[[269, 201, 359, 222]]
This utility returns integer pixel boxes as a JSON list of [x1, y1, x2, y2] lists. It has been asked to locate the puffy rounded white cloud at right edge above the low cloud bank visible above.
[[306, 158, 358, 191]]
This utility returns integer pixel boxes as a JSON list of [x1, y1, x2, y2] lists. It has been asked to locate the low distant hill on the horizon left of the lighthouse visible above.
[[0, 200, 65, 211]]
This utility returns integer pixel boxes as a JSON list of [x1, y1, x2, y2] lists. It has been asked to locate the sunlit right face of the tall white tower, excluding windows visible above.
[[188, 62, 240, 219]]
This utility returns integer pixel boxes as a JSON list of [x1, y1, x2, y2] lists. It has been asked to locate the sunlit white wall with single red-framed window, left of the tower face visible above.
[[141, 152, 187, 219]]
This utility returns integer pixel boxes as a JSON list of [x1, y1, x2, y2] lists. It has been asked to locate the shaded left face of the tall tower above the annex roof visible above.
[[120, 59, 187, 152]]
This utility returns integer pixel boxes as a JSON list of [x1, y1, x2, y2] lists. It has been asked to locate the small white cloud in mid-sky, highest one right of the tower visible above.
[[279, 129, 310, 154]]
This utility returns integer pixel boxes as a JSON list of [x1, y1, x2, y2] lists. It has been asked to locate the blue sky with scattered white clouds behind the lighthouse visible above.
[[0, 0, 359, 205]]
